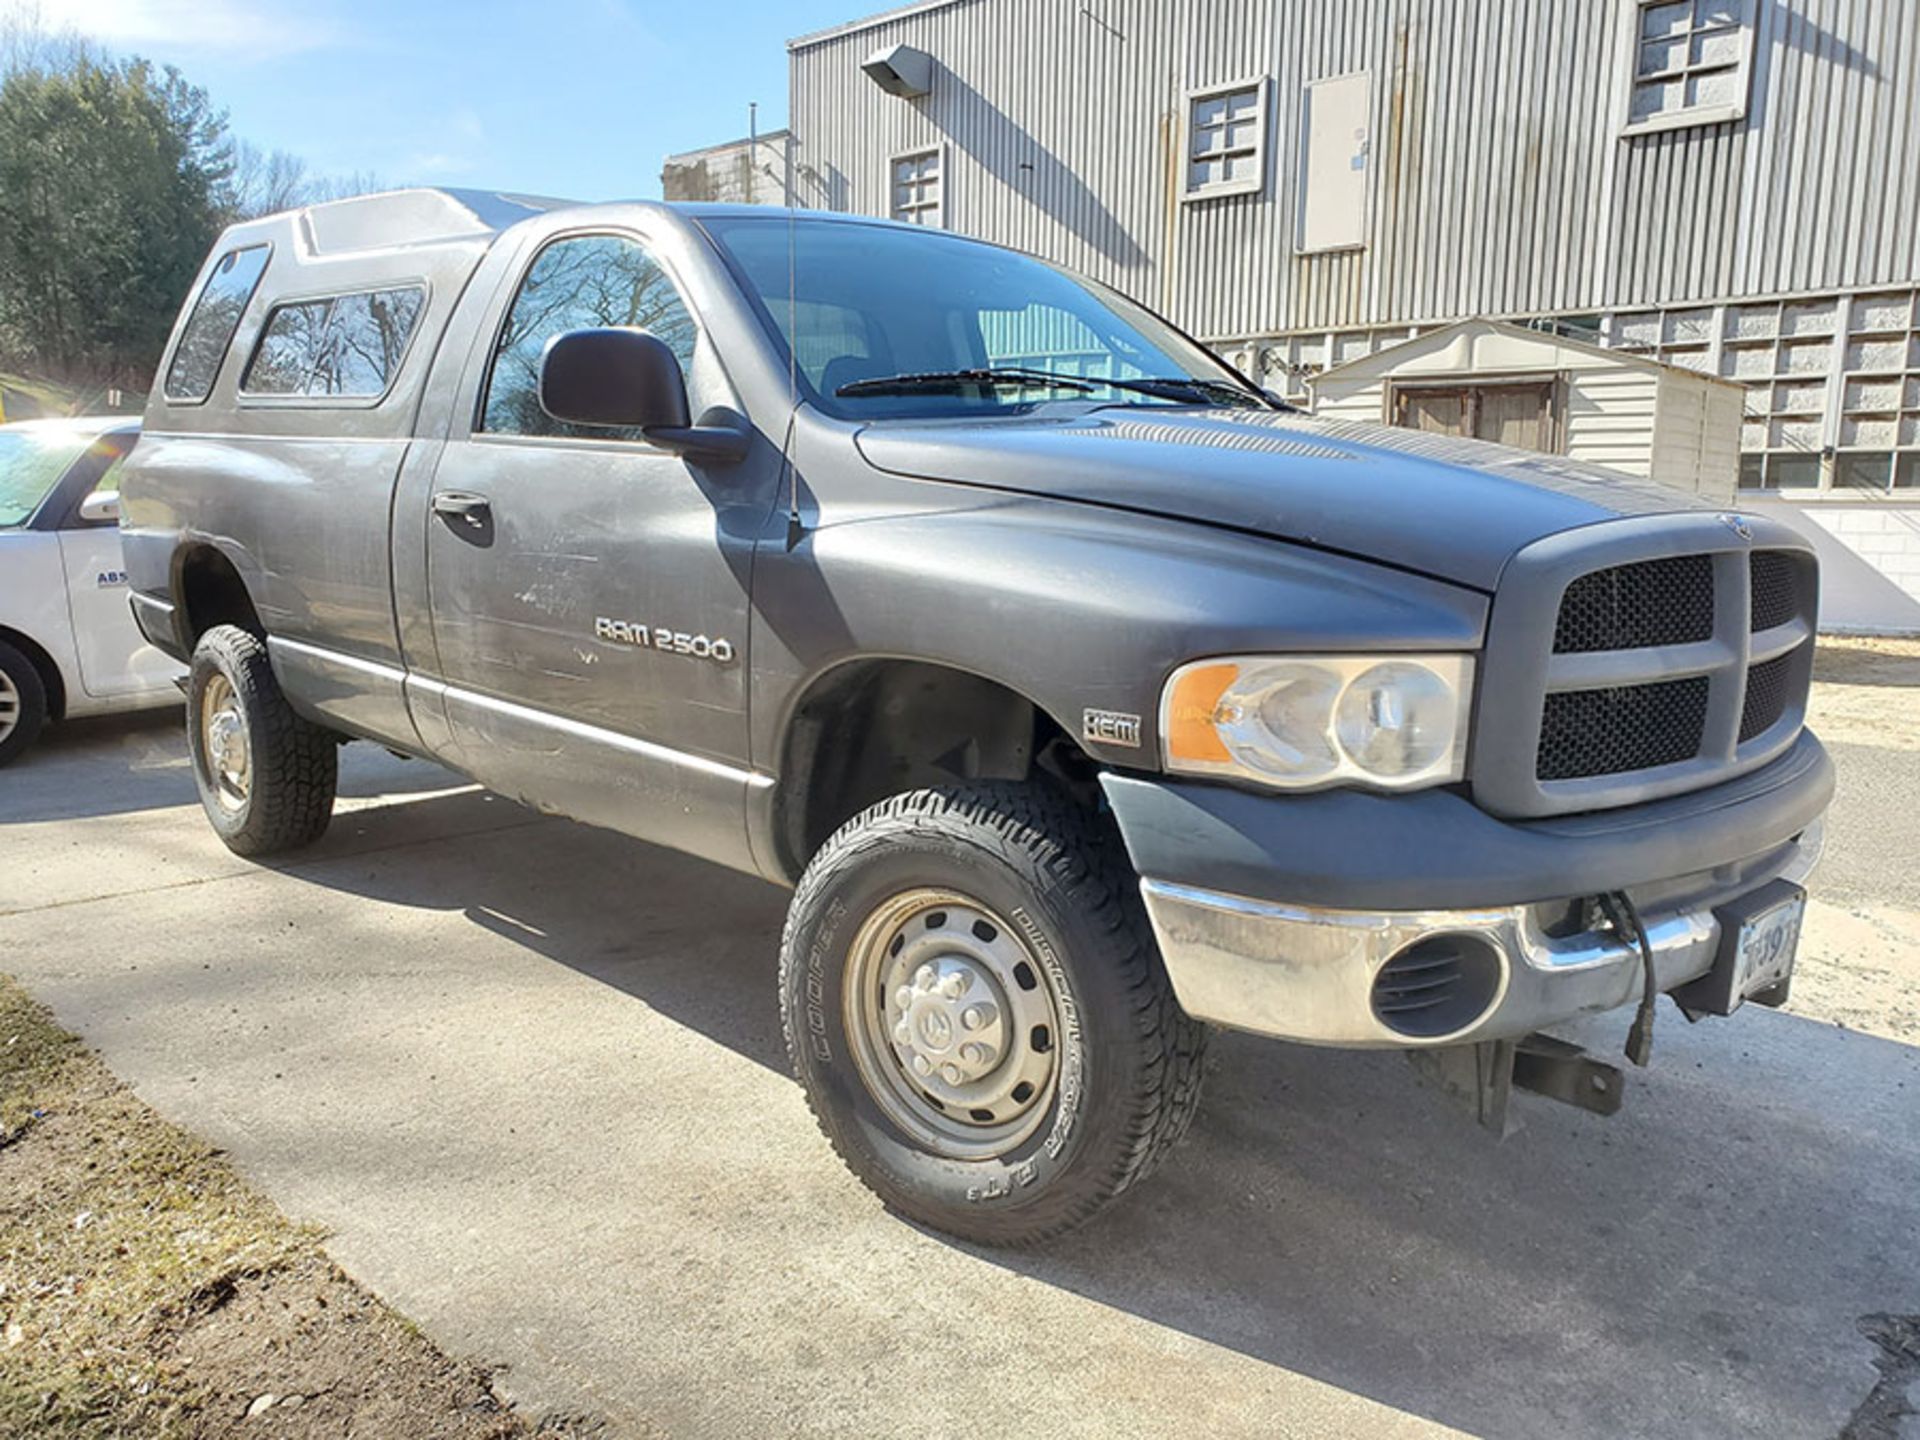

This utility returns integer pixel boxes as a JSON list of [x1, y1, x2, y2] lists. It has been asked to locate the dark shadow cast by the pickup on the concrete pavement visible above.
[[274, 783, 1920, 1436]]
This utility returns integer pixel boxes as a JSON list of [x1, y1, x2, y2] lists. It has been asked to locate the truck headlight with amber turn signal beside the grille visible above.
[[1160, 655, 1473, 789]]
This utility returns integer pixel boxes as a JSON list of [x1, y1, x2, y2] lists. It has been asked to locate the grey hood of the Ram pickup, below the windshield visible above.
[[856, 409, 1701, 591]]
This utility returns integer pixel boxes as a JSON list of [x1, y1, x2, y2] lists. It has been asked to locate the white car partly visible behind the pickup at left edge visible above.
[[0, 417, 182, 766]]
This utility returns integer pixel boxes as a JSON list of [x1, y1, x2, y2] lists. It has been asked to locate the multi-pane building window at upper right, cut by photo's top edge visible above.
[[1626, 0, 1755, 134]]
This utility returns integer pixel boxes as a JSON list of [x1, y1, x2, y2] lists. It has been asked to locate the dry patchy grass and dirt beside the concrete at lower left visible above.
[[0, 977, 599, 1440]]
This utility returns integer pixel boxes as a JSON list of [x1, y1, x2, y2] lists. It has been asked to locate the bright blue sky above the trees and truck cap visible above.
[[11, 0, 867, 200]]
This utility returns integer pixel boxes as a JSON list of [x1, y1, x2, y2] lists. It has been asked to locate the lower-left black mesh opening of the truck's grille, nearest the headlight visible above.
[[1534, 676, 1707, 780]]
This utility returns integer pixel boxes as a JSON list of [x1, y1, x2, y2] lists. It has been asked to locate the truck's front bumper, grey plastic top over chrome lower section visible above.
[[1106, 735, 1832, 1048]]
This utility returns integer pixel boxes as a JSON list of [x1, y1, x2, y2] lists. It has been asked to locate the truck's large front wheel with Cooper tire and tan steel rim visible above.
[[781, 785, 1206, 1246]]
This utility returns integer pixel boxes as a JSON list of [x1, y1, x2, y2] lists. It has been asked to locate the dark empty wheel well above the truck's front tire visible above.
[[774, 660, 1098, 877]]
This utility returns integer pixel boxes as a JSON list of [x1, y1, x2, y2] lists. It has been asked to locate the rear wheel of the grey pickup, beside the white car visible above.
[[186, 626, 340, 854]]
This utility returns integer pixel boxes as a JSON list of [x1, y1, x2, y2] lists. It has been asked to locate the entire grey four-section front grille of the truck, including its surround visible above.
[[1471, 513, 1818, 820]]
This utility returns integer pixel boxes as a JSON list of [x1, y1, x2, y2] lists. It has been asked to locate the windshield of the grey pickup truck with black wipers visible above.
[[707, 211, 1261, 419]]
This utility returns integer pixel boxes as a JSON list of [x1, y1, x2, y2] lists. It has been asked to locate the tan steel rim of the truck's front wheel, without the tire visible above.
[[845, 889, 1062, 1160]]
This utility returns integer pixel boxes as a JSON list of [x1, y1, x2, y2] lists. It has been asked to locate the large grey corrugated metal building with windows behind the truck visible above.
[[664, 0, 1920, 626]]
